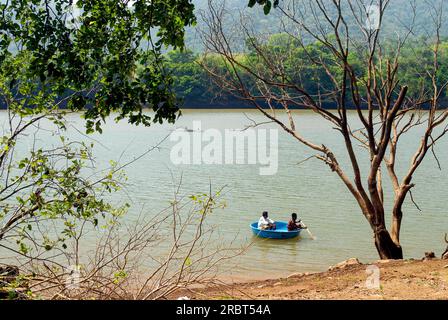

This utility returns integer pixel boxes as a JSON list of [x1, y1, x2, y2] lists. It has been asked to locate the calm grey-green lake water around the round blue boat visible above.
[[2, 110, 448, 279]]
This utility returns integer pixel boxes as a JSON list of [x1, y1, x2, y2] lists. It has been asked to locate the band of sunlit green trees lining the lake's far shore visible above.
[[165, 34, 448, 108]]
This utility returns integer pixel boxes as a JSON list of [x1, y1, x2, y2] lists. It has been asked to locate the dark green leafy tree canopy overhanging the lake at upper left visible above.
[[0, 0, 195, 131]]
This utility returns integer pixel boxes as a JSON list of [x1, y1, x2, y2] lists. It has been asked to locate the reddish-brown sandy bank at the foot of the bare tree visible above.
[[178, 259, 448, 300]]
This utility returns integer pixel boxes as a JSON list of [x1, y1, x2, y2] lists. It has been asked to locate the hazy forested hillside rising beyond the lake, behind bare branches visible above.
[[170, 0, 448, 108]]
